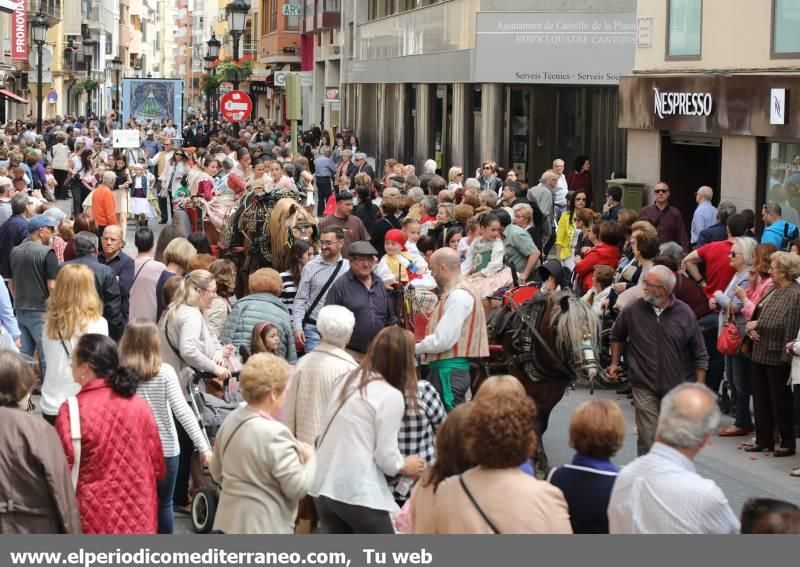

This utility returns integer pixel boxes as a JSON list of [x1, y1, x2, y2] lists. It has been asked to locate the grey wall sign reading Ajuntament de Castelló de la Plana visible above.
[[474, 11, 636, 85]]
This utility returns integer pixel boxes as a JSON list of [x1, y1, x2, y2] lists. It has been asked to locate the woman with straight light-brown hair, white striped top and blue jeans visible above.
[[119, 321, 212, 534]]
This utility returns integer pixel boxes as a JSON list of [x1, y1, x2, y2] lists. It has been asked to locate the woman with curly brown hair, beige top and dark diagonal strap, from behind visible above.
[[431, 396, 572, 534]]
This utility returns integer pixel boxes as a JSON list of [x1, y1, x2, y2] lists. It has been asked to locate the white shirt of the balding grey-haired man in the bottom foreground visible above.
[[608, 442, 739, 534]]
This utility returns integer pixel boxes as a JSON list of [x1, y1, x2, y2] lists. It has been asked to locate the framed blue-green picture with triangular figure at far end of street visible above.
[[122, 78, 183, 132]]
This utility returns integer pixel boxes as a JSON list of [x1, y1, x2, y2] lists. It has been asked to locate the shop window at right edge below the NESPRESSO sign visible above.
[[764, 142, 800, 226]]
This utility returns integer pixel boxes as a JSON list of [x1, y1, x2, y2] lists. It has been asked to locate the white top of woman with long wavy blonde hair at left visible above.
[[41, 317, 108, 415]]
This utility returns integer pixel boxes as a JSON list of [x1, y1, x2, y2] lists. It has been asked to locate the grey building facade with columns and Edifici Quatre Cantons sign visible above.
[[342, 0, 635, 204]]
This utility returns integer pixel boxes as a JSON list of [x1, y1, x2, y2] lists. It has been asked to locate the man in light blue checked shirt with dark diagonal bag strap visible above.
[[292, 227, 350, 353]]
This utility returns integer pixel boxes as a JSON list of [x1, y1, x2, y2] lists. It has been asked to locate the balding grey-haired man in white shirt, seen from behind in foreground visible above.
[[608, 382, 739, 534]]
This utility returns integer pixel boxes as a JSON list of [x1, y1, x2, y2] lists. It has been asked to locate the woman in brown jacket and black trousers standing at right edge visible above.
[[745, 252, 800, 457]]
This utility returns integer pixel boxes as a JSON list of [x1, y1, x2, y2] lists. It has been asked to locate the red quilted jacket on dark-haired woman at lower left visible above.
[[56, 378, 166, 534]]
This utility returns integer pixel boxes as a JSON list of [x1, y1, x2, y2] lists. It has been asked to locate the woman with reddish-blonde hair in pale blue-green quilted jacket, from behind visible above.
[[220, 268, 297, 364]]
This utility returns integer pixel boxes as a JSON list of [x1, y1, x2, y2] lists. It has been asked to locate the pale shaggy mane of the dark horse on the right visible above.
[[549, 292, 600, 361]]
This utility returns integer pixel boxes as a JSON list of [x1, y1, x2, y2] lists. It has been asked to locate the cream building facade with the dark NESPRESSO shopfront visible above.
[[619, 0, 800, 231]]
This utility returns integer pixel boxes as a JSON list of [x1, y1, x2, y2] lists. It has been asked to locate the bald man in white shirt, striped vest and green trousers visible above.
[[416, 248, 489, 412]]
